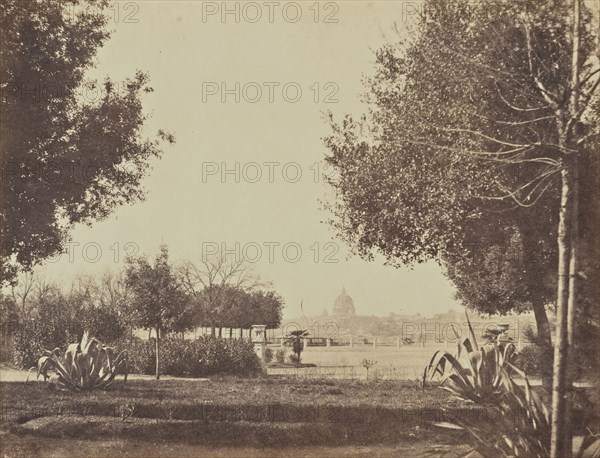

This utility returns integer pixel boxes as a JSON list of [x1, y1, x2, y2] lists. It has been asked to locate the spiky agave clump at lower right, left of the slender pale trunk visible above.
[[423, 317, 550, 457]]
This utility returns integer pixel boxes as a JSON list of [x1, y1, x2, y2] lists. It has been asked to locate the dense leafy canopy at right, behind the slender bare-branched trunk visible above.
[[325, 0, 600, 372]]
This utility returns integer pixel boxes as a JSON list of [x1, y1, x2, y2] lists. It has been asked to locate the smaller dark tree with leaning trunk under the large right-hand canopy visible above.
[[442, 216, 556, 348]]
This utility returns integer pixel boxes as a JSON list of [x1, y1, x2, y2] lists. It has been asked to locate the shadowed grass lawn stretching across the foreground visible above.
[[0, 377, 485, 456]]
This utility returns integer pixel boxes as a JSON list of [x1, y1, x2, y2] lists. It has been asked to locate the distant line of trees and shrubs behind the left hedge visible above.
[[0, 246, 284, 366]]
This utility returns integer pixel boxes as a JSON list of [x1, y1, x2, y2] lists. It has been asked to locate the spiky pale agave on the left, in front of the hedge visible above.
[[32, 331, 128, 391]]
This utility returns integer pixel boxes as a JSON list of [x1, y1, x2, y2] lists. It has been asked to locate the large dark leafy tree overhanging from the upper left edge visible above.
[[0, 0, 174, 284]]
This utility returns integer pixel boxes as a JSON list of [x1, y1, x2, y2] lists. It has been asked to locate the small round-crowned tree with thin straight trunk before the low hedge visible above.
[[125, 245, 188, 380]]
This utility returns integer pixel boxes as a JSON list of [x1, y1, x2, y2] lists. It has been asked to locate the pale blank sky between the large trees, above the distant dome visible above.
[[39, 1, 461, 318]]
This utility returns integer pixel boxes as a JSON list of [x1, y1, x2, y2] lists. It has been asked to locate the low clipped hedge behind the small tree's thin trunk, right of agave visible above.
[[125, 336, 263, 377]]
